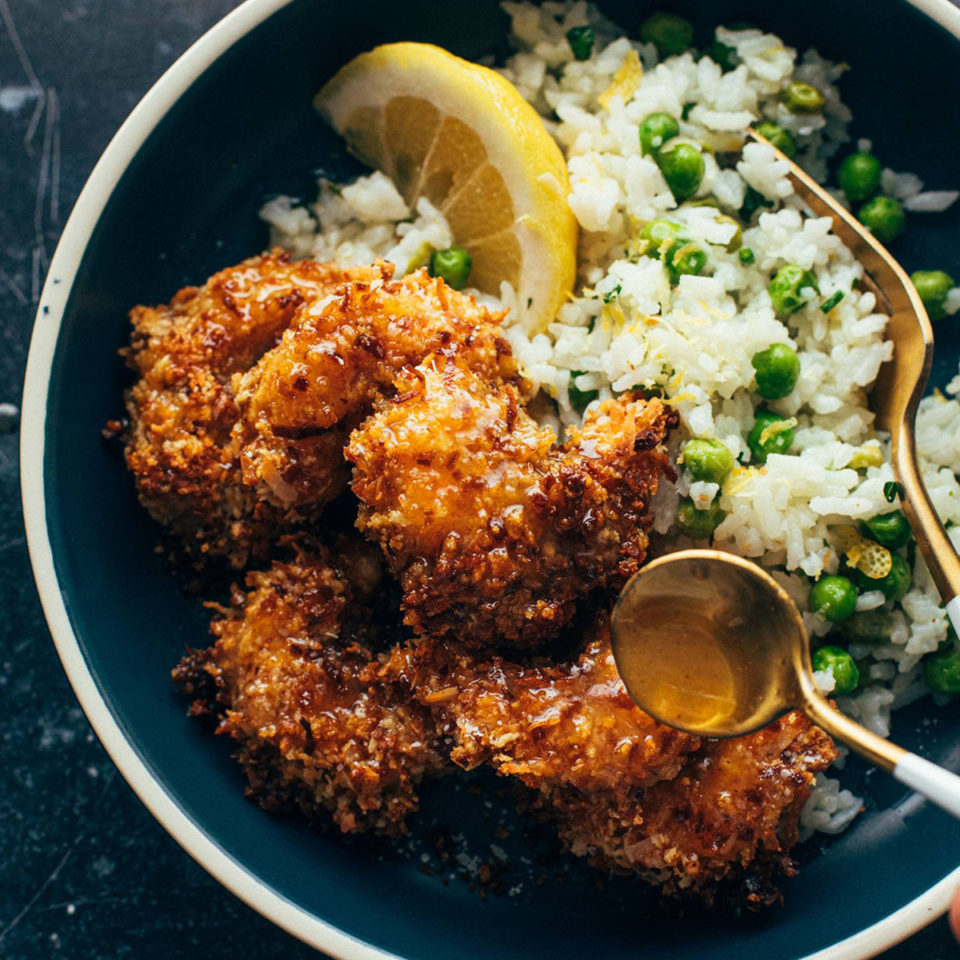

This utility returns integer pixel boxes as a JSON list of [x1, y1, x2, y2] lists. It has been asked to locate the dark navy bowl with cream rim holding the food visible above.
[[22, 0, 960, 960]]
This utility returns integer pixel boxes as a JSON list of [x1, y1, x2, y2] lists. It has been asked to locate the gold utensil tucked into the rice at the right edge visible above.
[[748, 129, 960, 634]]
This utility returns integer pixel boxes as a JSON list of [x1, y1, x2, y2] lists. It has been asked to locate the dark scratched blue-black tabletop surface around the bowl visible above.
[[0, 0, 958, 960]]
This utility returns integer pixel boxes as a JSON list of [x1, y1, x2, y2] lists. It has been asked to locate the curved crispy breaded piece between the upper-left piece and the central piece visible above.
[[236, 263, 516, 506]]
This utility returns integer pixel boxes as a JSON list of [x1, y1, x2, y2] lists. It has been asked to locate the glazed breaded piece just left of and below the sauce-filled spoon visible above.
[[384, 631, 699, 793]]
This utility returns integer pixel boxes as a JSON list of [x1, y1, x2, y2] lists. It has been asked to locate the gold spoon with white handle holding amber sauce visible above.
[[611, 550, 960, 817]]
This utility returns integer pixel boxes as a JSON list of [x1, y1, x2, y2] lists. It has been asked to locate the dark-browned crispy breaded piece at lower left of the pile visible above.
[[174, 544, 445, 834]]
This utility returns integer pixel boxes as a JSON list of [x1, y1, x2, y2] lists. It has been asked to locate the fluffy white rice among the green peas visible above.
[[262, 0, 960, 833]]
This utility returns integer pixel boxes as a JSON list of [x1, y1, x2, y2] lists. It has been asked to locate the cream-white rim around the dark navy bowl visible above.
[[20, 0, 960, 960]]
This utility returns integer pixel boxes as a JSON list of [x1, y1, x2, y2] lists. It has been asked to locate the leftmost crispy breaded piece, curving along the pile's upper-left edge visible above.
[[125, 253, 371, 568]]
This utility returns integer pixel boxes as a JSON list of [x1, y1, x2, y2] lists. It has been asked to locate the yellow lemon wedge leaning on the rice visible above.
[[314, 43, 577, 328]]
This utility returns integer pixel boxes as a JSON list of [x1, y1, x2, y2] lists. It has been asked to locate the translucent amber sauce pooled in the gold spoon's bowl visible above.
[[613, 563, 793, 736]]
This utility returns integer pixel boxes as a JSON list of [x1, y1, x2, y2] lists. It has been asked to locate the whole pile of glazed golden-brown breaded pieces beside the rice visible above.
[[126, 253, 835, 908]]
